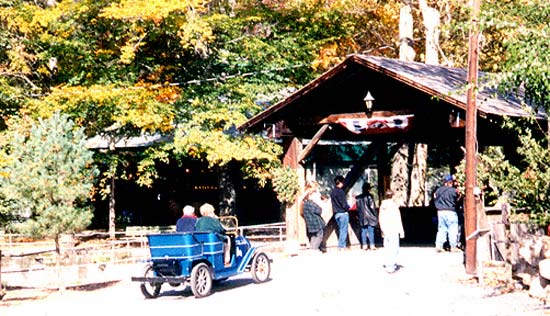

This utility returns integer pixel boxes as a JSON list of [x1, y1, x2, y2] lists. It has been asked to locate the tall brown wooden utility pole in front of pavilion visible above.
[[464, 0, 481, 274]]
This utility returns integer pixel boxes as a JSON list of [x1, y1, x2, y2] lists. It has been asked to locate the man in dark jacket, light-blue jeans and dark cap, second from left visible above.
[[330, 176, 350, 250]]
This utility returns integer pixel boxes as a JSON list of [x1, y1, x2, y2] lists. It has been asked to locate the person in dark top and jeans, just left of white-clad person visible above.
[[355, 182, 378, 250]]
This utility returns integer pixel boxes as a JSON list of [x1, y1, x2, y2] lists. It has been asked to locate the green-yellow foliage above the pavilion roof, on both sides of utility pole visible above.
[[441, 0, 550, 111]]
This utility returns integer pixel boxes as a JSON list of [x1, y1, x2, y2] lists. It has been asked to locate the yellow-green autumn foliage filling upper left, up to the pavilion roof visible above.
[[0, 0, 406, 189]]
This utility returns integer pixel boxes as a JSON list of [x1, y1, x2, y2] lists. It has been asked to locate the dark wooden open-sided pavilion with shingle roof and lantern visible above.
[[239, 54, 544, 251]]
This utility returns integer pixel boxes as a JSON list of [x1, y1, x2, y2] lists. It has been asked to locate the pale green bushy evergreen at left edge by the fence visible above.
[[0, 113, 96, 237]]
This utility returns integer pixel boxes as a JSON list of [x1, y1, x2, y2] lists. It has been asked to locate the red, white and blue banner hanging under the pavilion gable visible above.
[[336, 114, 414, 134]]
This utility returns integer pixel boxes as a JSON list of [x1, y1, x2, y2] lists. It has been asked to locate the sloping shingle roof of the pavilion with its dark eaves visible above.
[[239, 54, 545, 131]]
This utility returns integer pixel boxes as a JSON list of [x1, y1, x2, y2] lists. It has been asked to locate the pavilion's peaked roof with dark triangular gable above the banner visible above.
[[239, 54, 544, 140]]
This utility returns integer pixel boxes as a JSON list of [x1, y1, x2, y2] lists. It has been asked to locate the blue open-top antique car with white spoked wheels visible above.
[[132, 217, 271, 298]]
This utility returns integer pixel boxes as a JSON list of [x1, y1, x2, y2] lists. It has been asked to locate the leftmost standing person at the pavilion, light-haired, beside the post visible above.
[[302, 181, 325, 252]]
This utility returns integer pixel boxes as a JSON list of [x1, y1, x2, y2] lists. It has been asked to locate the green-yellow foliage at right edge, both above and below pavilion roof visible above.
[[436, 0, 550, 232]]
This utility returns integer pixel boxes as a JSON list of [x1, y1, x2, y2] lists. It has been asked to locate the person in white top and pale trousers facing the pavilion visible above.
[[378, 190, 405, 273]]
